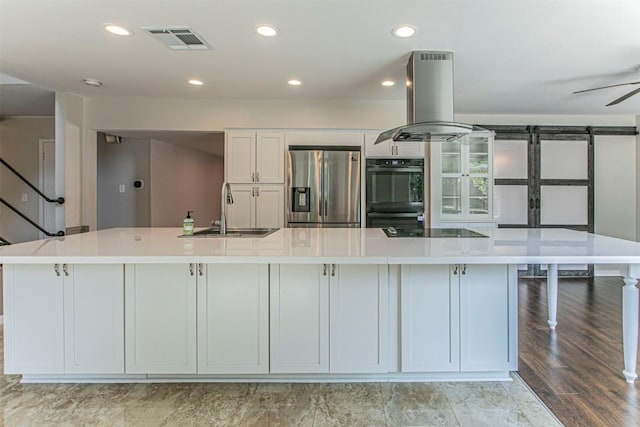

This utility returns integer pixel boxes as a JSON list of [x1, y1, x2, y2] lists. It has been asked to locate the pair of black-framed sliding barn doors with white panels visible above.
[[494, 128, 594, 276]]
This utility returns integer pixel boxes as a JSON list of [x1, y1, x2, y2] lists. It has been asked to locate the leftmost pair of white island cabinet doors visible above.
[[4, 264, 124, 374]]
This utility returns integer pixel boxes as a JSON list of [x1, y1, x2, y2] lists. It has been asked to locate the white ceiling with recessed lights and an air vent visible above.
[[0, 0, 640, 114]]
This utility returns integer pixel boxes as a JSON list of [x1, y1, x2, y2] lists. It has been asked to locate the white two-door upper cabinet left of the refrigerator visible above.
[[224, 131, 284, 184]]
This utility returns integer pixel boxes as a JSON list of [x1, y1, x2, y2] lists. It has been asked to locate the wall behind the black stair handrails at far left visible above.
[[0, 117, 57, 243]]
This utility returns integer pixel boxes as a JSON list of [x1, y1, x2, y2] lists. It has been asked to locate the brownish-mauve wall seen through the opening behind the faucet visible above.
[[149, 140, 224, 227]]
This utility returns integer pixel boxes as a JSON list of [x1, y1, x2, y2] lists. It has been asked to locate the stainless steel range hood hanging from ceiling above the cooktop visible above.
[[375, 50, 486, 144]]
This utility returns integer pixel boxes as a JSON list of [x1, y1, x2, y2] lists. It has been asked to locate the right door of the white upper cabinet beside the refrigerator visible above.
[[255, 132, 284, 184]]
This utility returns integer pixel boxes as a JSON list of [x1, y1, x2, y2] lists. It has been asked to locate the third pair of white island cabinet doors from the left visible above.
[[271, 264, 389, 374]]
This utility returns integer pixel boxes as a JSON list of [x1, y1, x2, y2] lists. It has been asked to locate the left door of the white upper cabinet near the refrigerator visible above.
[[224, 132, 256, 183]]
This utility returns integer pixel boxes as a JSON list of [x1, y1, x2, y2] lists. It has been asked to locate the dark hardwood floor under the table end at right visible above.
[[518, 277, 640, 427]]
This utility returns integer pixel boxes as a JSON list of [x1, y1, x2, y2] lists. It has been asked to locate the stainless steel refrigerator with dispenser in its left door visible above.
[[286, 146, 360, 227]]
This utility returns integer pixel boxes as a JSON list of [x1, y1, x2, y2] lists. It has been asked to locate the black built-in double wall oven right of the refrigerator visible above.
[[366, 159, 425, 228]]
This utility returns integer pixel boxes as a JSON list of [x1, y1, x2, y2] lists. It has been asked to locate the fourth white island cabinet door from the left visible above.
[[198, 264, 269, 374]]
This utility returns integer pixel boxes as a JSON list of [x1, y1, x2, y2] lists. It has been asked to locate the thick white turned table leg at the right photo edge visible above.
[[622, 265, 640, 383]]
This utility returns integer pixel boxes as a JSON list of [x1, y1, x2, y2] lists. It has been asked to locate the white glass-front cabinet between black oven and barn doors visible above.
[[431, 132, 493, 221]]
